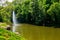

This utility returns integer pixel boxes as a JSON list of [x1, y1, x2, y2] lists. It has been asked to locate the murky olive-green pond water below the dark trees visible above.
[[17, 24, 60, 40]]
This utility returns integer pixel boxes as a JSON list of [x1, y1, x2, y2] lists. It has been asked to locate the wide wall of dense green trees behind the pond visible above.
[[0, 0, 60, 26]]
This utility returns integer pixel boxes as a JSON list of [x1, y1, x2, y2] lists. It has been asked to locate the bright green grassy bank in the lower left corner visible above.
[[0, 28, 21, 40]]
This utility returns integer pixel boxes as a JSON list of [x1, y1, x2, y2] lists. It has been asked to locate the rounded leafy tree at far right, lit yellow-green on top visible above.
[[47, 2, 60, 25]]
